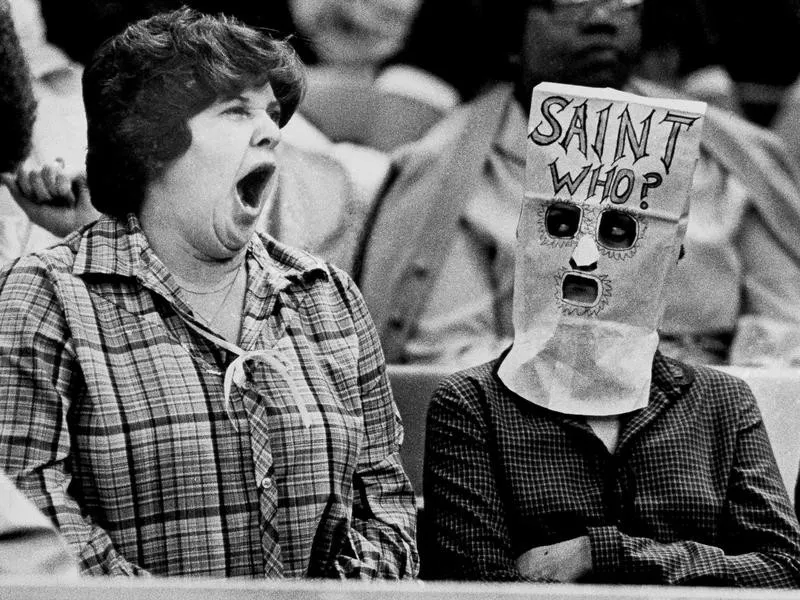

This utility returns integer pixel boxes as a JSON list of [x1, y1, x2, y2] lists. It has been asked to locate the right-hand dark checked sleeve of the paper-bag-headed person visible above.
[[589, 392, 800, 588]]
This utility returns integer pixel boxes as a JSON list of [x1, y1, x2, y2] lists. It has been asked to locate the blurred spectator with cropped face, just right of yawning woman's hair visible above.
[[287, 0, 459, 151]]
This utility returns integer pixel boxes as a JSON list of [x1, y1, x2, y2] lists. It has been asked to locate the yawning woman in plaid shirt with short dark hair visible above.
[[0, 9, 417, 578]]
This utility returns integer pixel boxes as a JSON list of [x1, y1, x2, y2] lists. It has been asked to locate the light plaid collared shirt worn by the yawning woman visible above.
[[0, 216, 418, 578]]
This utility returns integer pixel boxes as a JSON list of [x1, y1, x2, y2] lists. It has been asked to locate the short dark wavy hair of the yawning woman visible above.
[[83, 8, 305, 218]]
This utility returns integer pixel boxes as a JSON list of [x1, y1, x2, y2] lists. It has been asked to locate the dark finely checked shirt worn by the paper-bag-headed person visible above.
[[424, 354, 800, 587]]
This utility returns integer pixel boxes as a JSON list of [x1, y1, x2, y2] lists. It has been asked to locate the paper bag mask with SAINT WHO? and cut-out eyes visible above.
[[499, 83, 705, 416]]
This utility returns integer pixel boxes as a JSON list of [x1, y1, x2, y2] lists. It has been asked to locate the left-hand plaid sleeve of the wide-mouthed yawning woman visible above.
[[0, 257, 147, 575]]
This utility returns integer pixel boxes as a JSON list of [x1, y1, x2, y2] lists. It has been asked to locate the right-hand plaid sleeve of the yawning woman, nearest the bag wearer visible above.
[[334, 274, 419, 579]]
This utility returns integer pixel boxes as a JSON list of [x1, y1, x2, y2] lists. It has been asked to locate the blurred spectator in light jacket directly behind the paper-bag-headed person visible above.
[[355, 0, 800, 365]]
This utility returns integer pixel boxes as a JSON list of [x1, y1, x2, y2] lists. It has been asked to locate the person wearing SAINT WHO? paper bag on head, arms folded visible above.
[[424, 84, 800, 587]]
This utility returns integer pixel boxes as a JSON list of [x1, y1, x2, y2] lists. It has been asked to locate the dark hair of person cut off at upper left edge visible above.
[[0, 0, 36, 171]]
